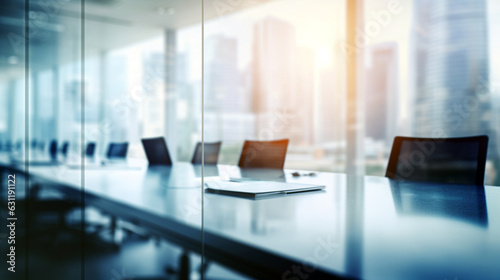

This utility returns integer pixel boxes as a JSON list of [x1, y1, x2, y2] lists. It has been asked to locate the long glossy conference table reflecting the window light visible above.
[[0, 155, 500, 280]]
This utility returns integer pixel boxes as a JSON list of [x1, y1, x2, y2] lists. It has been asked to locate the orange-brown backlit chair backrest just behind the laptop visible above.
[[238, 139, 288, 169]]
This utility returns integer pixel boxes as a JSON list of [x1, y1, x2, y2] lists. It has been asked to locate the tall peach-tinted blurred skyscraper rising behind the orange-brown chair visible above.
[[252, 17, 303, 142]]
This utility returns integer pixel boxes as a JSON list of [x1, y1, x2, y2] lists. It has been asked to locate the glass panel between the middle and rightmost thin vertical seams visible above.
[[85, 0, 202, 279]]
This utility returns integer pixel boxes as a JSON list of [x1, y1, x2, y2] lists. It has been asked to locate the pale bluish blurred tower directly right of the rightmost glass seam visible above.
[[204, 34, 254, 147]]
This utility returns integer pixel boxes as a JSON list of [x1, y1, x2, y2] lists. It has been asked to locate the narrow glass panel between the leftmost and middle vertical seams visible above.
[[29, 0, 84, 279]]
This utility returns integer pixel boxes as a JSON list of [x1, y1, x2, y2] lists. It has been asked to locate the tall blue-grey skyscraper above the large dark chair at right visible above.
[[413, 0, 493, 140]]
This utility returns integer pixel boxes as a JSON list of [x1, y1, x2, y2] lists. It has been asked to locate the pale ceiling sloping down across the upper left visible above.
[[0, 0, 272, 78]]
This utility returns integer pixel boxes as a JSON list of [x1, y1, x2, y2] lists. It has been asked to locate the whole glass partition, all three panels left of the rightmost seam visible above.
[[0, 0, 202, 279]]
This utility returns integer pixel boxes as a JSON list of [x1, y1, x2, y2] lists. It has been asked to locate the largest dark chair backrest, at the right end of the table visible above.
[[385, 135, 488, 185]]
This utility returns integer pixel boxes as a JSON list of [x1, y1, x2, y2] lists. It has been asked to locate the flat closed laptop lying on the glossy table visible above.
[[205, 180, 325, 199]]
